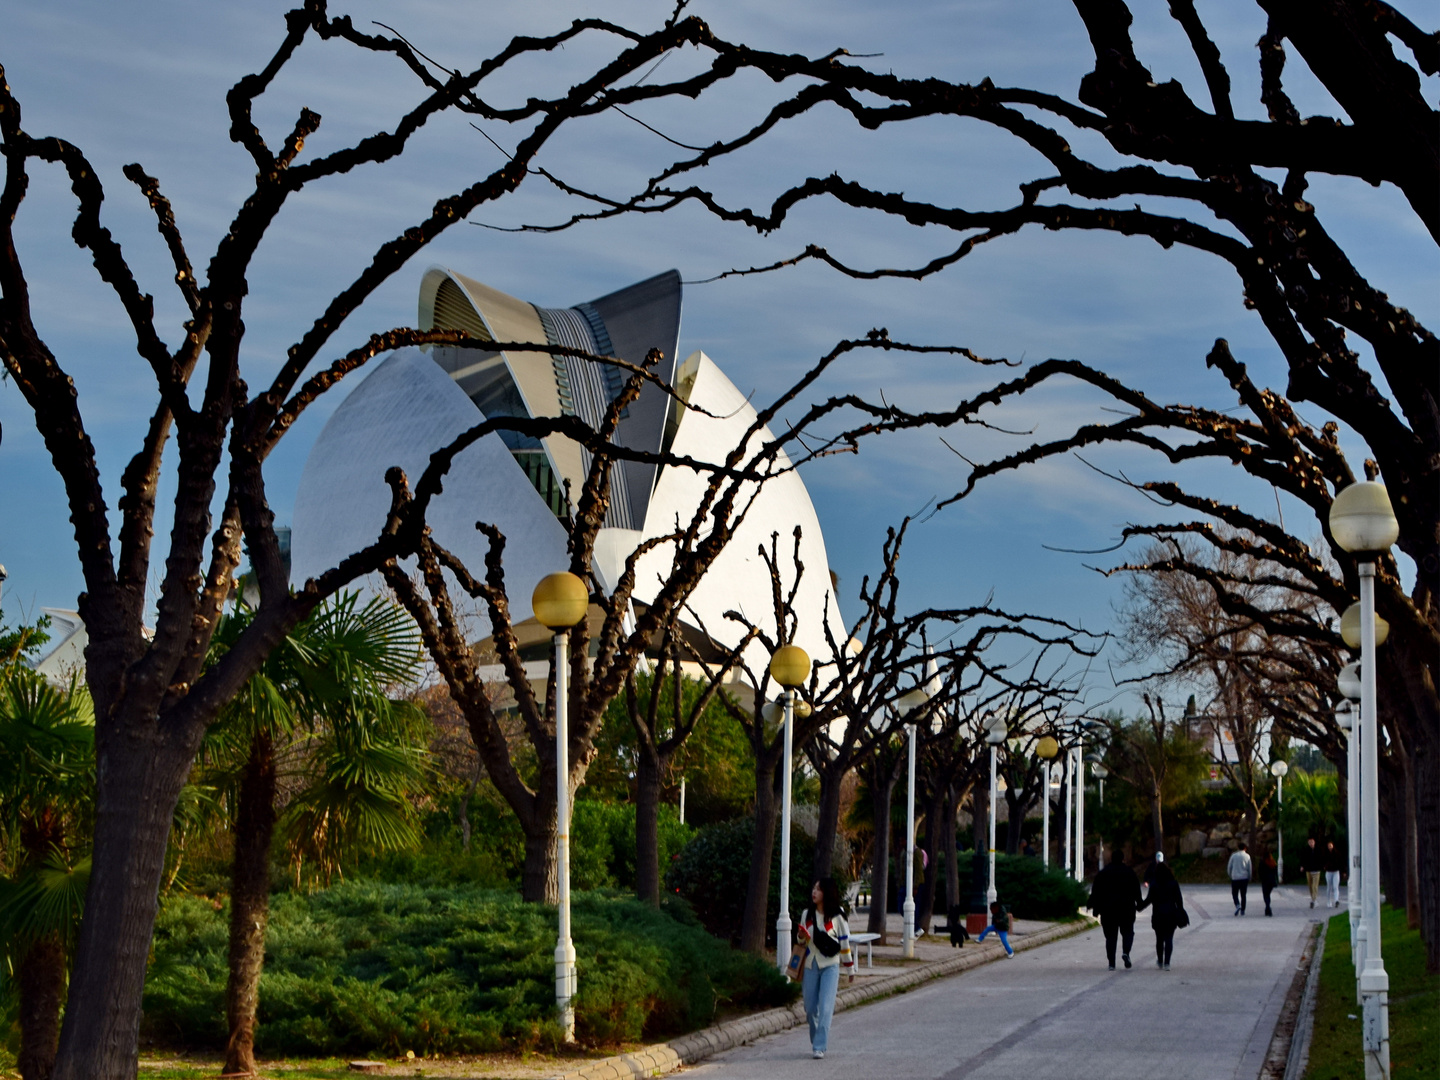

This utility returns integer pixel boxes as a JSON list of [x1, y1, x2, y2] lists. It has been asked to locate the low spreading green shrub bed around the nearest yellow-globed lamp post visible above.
[[144, 881, 793, 1054]]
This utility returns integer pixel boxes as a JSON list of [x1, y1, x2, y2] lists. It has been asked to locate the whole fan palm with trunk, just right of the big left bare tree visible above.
[[204, 593, 425, 1074]]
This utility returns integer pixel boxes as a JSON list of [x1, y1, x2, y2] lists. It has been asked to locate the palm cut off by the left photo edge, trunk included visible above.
[[0, 664, 95, 1080]]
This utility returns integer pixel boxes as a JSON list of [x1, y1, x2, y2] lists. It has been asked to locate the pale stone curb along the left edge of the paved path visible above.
[[553, 917, 1099, 1080]]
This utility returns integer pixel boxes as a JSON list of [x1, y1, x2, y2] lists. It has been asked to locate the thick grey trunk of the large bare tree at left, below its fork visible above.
[[53, 719, 203, 1080]]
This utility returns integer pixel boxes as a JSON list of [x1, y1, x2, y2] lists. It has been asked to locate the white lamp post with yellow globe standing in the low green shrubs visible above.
[[530, 572, 590, 1043]]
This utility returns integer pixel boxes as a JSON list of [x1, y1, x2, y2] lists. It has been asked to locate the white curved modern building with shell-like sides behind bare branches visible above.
[[292, 268, 847, 671]]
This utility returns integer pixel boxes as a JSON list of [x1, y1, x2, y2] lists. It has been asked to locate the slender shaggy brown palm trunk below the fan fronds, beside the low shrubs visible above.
[[222, 732, 275, 1076]]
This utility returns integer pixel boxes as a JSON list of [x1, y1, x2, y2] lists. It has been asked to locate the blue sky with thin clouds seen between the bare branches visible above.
[[0, 0, 1440, 720]]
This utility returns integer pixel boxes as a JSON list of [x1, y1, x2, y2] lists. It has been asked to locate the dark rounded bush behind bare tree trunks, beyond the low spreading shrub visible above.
[[665, 816, 848, 942]]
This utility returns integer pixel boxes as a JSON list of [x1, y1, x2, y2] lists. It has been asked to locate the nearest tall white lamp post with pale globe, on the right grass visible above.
[[1329, 481, 1400, 1080]]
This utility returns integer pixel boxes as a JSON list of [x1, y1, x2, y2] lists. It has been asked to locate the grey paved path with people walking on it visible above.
[[687, 886, 1331, 1080]]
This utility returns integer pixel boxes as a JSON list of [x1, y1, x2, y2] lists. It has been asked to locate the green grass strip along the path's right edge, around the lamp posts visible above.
[[1305, 907, 1440, 1080]]
